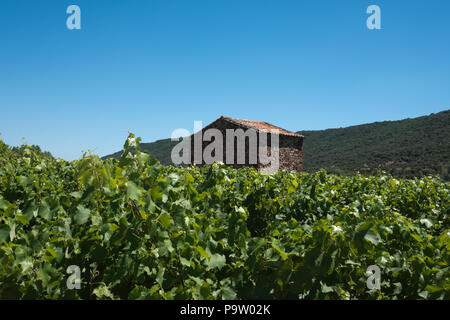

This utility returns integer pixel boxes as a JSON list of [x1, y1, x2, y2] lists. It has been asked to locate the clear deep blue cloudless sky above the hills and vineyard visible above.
[[0, 0, 450, 160]]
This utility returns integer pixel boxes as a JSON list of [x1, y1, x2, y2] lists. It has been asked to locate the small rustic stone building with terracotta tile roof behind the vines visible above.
[[190, 116, 304, 172]]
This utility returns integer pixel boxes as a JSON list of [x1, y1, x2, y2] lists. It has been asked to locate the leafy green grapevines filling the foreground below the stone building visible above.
[[0, 134, 450, 300]]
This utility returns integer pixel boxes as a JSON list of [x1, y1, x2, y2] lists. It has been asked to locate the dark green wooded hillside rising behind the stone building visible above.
[[104, 110, 450, 180]]
